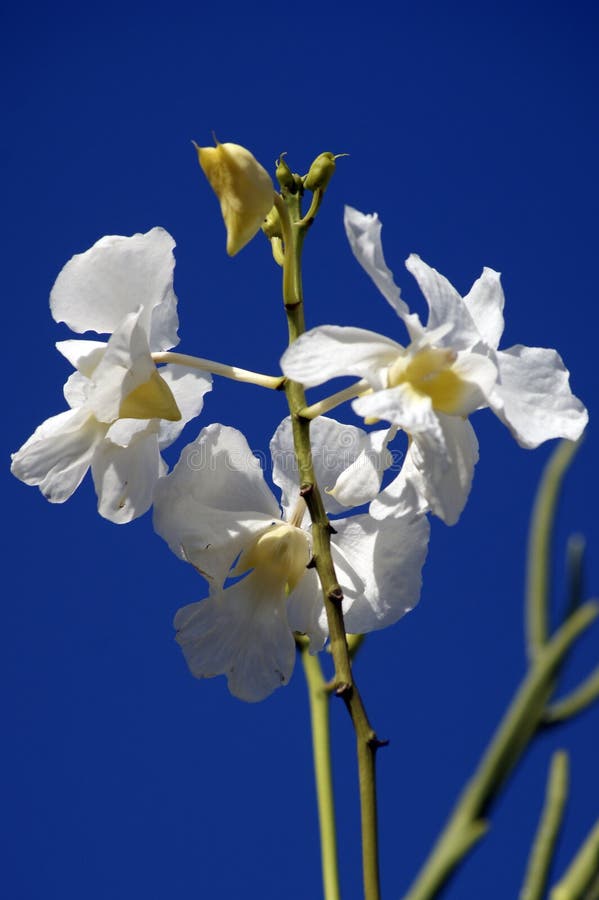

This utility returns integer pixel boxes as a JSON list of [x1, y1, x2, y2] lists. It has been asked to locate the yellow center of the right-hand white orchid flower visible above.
[[388, 347, 465, 415]]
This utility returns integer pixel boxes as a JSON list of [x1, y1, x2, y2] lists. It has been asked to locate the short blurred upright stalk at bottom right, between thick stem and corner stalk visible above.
[[520, 751, 568, 900]]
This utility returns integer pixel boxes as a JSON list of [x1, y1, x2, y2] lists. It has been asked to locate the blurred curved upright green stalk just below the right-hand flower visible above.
[[526, 441, 580, 660]]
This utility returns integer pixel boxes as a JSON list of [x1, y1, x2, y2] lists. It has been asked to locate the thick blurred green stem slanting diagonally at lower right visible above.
[[405, 603, 599, 900]]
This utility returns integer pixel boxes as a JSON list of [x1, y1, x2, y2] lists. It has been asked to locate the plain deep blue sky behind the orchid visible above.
[[0, 0, 599, 900]]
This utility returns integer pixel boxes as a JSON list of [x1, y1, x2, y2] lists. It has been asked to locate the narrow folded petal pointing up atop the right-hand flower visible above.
[[343, 206, 422, 338]]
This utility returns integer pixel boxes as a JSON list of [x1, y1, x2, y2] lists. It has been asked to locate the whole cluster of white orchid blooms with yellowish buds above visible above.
[[12, 142, 587, 701]]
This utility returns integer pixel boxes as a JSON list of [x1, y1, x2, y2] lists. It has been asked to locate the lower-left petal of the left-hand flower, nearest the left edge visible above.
[[11, 409, 106, 503]]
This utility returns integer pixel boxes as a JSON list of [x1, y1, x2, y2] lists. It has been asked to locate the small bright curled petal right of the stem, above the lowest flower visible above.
[[328, 425, 397, 507]]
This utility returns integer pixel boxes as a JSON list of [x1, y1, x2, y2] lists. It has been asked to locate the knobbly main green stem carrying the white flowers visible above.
[[275, 185, 380, 900]]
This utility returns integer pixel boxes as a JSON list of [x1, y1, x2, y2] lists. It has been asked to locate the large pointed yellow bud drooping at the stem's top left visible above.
[[195, 141, 274, 256]]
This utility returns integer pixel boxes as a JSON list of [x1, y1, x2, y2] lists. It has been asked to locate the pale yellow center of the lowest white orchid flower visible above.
[[234, 524, 310, 591]]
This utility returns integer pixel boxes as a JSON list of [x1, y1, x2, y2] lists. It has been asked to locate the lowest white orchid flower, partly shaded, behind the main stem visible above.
[[154, 423, 429, 701]]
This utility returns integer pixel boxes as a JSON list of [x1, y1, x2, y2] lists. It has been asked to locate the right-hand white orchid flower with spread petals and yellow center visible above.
[[281, 207, 588, 524]]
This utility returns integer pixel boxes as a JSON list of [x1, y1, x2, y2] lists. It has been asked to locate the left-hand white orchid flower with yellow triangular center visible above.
[[11, 228, 211, 523]]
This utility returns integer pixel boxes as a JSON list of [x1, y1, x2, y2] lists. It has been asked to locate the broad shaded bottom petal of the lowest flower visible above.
[[175, 573, 295, 702]]
